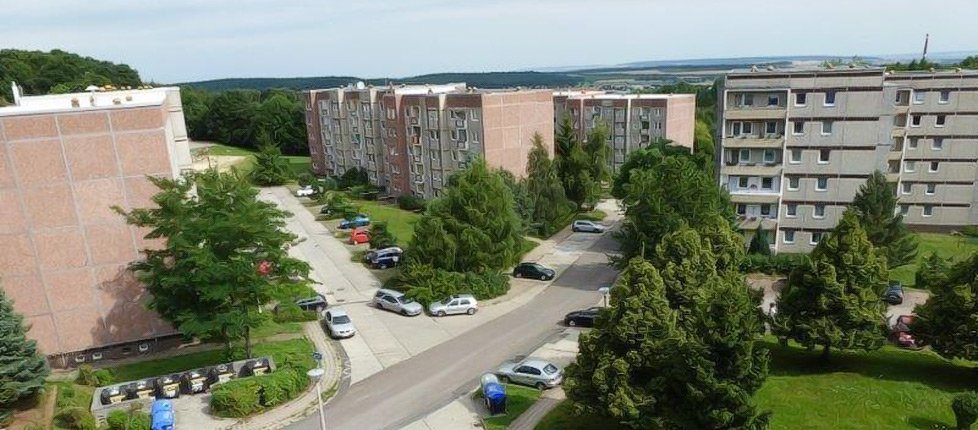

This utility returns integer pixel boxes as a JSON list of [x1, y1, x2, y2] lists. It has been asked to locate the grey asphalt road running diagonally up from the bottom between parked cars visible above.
[[287, 235, 617, 430]]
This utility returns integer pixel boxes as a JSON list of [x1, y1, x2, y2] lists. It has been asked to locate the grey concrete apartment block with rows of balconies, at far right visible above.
[[717, 67, 978, 252]]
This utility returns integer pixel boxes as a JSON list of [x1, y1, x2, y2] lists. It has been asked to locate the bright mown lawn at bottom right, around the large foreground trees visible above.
[[537, 338, 978, 430]]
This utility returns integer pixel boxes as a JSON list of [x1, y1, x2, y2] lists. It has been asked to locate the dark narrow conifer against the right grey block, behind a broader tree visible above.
[[852, 170, 917, 268]]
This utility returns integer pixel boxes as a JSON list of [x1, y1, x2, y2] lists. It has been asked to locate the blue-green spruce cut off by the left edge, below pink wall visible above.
[[0, 288, 51, 416]]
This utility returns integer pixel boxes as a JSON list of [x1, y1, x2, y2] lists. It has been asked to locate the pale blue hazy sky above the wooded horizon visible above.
[[0, 0, 978, 83]]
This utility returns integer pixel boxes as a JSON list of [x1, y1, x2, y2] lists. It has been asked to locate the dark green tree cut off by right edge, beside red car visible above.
[[911, 253, 978, 360]]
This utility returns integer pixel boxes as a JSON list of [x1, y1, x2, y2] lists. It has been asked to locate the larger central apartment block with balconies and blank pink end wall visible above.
[[304, 83, 553, 198]]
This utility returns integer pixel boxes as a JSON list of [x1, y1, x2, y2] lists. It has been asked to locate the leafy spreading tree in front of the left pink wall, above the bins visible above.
[[116, 169, 310, 356]]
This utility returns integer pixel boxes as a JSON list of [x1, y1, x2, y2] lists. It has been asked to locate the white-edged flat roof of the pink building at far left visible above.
[[0, 87, 180, 116]]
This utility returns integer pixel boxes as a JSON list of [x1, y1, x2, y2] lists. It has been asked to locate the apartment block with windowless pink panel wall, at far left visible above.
[[0, 86, 192, 366]]
